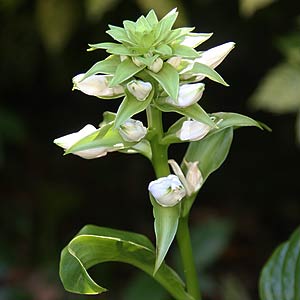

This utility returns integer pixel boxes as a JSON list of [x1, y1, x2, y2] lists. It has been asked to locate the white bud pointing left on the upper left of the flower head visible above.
[[72, 74, 124, 99]]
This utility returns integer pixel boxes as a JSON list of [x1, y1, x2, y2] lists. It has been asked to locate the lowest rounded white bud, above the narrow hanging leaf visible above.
[[148, 174, 186, 207]]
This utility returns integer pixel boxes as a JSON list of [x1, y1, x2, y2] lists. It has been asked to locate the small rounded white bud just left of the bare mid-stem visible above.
[[119, 119, 147, 142]]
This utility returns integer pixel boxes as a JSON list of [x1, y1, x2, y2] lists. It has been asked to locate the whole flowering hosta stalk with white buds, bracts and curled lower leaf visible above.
[[54, 9, 268, 300]]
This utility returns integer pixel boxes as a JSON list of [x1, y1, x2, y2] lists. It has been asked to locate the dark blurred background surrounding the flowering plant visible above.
[[0, 0, 300, 300]]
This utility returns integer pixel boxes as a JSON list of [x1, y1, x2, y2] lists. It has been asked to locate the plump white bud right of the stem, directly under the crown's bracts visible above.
[[165, 82, 205, 107]]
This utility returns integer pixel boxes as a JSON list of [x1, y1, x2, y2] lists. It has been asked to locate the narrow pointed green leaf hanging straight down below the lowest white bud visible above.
[[149, 194, 180, 274]]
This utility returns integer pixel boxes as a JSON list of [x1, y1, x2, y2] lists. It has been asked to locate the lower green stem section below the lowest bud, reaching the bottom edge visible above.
[[176, 215, 202, 300]]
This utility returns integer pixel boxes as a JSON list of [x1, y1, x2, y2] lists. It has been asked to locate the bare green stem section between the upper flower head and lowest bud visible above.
[[147, 105, 170, 178]]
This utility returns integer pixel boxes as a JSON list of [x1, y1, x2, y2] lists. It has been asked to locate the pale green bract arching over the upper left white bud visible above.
[[82, 55, 121, 80]]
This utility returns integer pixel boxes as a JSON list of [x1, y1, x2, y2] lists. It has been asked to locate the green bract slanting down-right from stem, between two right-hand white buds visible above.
[[156, 103, 216, 128]]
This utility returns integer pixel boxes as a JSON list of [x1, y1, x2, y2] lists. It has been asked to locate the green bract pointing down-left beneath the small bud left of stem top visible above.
[[114, 89, 154, 128]]
